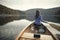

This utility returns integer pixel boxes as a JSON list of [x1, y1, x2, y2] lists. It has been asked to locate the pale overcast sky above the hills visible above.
[[0, 0, 60, 10]]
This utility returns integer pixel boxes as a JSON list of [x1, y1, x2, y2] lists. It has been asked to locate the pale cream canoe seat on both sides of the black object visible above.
[[21, 33, 53, 40]]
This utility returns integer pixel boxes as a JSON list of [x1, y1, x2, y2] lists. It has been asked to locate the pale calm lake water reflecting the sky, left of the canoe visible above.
[[0, 19, 31, 40]]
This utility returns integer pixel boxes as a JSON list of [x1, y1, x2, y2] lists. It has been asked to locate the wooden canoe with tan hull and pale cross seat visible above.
[[16, 23, 55, 40]]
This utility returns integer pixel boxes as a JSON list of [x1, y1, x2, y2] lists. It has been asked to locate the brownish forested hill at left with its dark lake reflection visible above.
[[0, 5, 23, 25]]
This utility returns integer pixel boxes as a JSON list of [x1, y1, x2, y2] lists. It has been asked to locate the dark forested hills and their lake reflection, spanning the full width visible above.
[[0, 4, 60, 25]]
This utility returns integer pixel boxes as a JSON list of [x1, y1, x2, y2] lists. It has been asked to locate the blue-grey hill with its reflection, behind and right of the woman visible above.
[[25, 7, 60, 22]]
